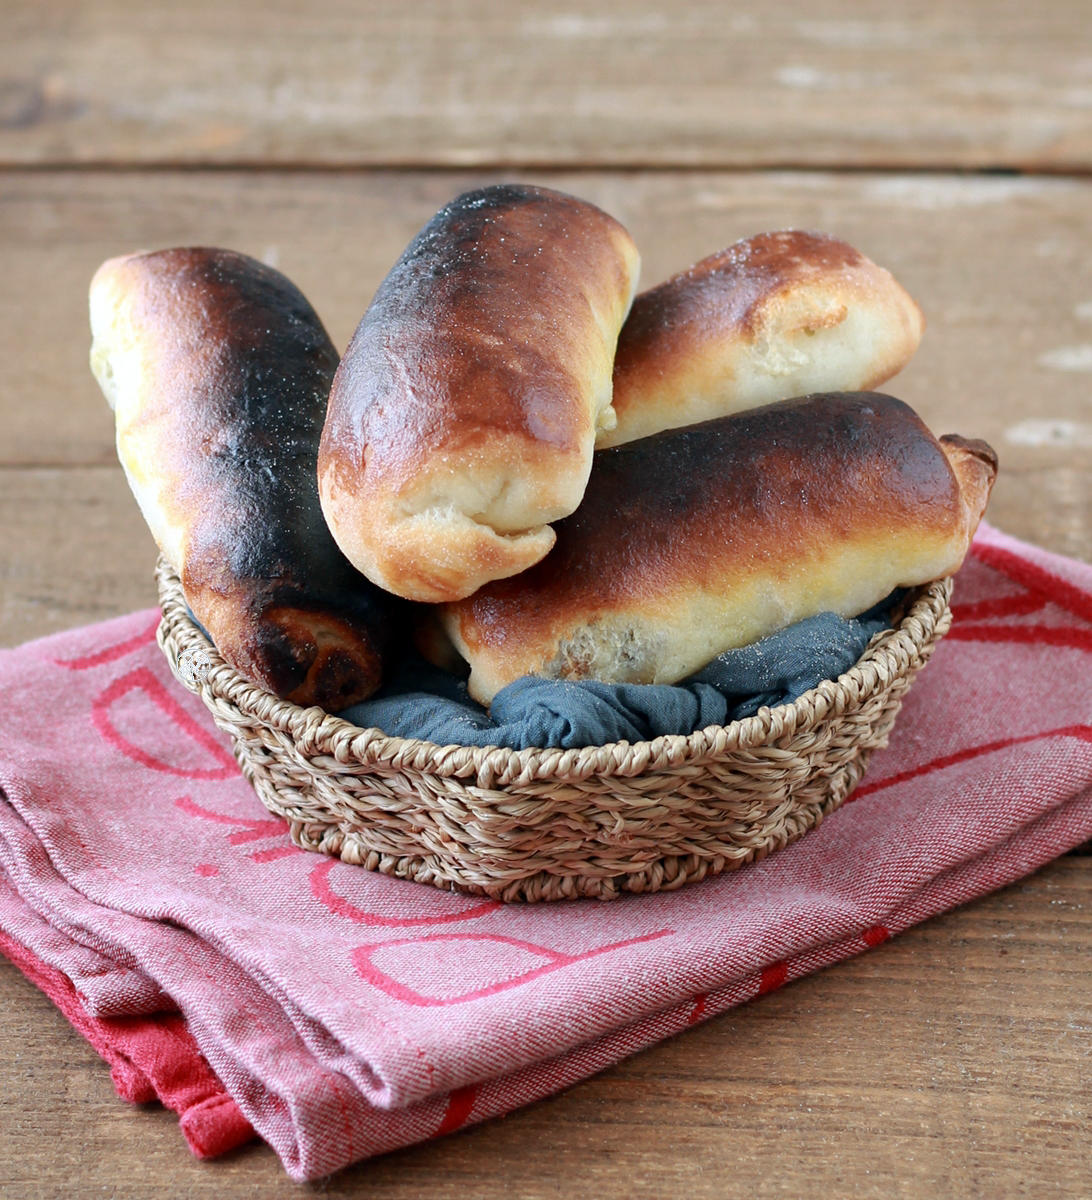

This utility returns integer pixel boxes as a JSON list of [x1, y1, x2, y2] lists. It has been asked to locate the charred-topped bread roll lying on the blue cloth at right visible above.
[[426, 392, 997, 703]]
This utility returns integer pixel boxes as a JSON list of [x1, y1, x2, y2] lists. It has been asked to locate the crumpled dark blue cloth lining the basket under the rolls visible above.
[[338, 589, 906, 750]]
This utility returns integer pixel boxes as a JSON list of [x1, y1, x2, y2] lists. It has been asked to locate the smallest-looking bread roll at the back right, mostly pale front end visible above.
[[599, 229, 924, 446]]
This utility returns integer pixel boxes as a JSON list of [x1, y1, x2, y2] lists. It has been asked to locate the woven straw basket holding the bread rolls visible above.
[[157, 560, 952, 901]]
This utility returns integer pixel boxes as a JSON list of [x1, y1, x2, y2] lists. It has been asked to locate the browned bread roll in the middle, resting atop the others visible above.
[[318, 185, 640, 601]]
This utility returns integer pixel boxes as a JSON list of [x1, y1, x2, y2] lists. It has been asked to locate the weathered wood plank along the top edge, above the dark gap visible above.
[[0, 0, 1092, 170]]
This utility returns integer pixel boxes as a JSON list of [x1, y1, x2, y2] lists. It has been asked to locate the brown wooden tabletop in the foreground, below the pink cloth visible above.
[[0, 858, 1092, 1200]]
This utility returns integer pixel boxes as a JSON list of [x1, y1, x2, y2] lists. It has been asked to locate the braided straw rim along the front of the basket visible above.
[[156, 556, 952, 781]]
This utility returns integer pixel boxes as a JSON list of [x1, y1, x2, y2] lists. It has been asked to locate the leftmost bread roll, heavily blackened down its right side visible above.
[[90, 248, 401, 709]]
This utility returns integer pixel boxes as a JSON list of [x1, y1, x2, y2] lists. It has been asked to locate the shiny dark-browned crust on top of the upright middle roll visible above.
[[319, 184, 624, 468]]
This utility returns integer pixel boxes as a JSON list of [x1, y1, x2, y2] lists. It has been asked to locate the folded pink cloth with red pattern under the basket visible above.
[[0, 528, 1092, 1180]]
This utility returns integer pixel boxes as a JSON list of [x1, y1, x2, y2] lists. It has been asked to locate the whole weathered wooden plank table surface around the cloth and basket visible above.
[[0, 0, 1092, 1198]]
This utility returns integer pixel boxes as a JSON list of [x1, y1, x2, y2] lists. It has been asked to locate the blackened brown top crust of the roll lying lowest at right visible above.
[[465, 392, 958, 619]]
